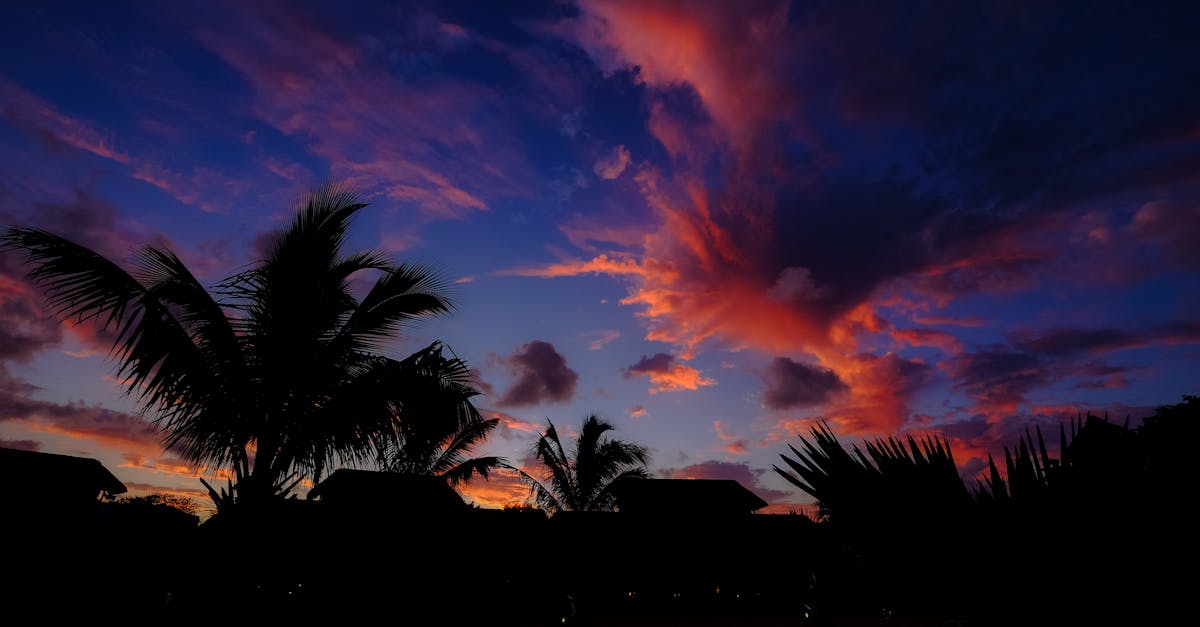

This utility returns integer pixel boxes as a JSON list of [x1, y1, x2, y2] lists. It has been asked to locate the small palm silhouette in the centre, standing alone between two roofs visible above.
[[521, 414, 649, 513]]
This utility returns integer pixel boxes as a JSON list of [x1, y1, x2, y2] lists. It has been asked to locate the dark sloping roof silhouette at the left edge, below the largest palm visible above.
[[0, 448, 128, 501]]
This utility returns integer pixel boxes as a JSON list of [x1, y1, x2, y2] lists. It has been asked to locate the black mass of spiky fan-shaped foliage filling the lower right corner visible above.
[[776, 396, 1200, 625]]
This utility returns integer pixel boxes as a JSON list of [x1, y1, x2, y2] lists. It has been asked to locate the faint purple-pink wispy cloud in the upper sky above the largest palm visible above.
[[193, 2, 541, 221]]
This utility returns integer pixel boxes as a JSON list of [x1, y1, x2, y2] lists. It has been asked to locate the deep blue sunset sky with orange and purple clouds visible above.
[[0, 0, 1200, 512]]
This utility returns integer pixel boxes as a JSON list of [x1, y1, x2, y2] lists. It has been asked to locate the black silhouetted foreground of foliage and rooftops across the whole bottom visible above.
[[0, 396, 1200, 626]]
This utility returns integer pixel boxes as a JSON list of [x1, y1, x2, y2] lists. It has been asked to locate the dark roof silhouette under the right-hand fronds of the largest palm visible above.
[[308, 468, 468, 512]]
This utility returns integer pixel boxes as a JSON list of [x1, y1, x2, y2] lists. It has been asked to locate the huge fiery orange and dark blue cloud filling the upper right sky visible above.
[[521, 1, 1200, 429]]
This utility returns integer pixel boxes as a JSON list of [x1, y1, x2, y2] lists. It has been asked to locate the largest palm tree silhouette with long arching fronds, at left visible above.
[[0, 180, 492, 502]]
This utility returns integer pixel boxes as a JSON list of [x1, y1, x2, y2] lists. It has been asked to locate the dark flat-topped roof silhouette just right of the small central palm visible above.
[[612, 479, 767, 515]]
